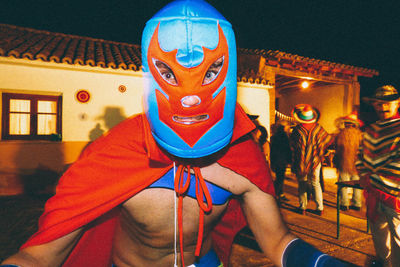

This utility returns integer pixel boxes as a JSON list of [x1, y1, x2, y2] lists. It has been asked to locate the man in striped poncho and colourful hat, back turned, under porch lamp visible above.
[[290, 104, 332, 215]]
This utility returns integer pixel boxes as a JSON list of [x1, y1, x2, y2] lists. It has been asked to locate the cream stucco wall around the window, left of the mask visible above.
[[0, 57, 143, 142]]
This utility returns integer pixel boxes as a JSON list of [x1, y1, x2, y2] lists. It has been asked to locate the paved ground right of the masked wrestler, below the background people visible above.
[[231, 171, 375, 267]]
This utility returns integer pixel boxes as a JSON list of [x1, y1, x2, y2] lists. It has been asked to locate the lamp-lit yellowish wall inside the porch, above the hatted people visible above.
[[279, 84, 351, 133]]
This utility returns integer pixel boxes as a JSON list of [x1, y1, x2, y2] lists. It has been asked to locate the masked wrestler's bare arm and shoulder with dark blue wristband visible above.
[[201, 163, 345, 267]]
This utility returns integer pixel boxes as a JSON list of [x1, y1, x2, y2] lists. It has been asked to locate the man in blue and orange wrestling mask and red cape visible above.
[[3, 0, 341, 267]]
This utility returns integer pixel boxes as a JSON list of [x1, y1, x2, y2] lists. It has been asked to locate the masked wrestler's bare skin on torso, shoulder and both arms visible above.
[[3, 163, 295, 267]]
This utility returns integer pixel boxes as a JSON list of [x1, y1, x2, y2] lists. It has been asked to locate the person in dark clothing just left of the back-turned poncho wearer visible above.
[[270, 121, 292, 202]]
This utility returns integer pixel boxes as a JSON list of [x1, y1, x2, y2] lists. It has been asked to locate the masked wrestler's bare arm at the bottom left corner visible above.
[[2, 228, 82, 267]]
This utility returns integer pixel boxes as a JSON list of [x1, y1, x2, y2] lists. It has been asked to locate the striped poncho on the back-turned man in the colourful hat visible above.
[[290, 123, 332, 176]]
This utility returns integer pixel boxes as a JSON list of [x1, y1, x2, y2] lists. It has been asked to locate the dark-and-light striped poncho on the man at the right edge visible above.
[[356, 117, 400, 197]]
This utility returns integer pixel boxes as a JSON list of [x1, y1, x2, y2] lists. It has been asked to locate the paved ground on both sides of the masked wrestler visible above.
[[0, 170, 375, 267]]
